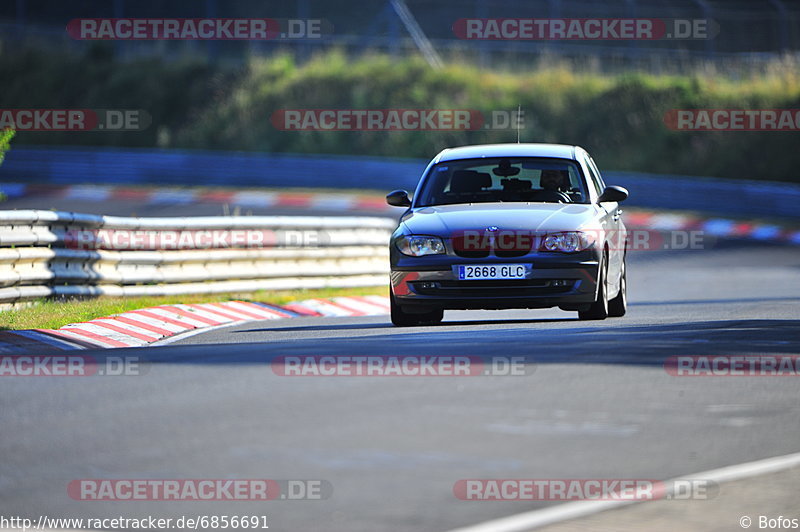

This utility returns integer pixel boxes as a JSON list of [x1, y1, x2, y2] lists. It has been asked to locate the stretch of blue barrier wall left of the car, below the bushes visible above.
[[0, 146, 425, 190]]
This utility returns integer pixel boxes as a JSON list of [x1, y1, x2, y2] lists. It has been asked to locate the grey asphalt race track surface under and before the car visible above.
[[0, 239, 800, 532]]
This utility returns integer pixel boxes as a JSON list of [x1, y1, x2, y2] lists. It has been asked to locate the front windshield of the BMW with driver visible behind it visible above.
[[415, 157, 589, 207]]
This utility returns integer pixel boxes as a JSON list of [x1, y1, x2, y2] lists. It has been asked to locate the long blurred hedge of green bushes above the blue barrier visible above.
[[0, 44, 800, 181]]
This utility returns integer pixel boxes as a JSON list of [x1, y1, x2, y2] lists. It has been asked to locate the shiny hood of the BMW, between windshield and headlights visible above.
[[402, 203, 598, 236]]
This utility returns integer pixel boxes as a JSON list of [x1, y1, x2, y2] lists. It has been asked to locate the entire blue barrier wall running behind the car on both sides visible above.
[[0, 146, 800, 217]]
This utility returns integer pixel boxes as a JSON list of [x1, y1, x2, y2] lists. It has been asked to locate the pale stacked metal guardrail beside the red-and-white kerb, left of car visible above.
[[0, 210, 394, 303]]
